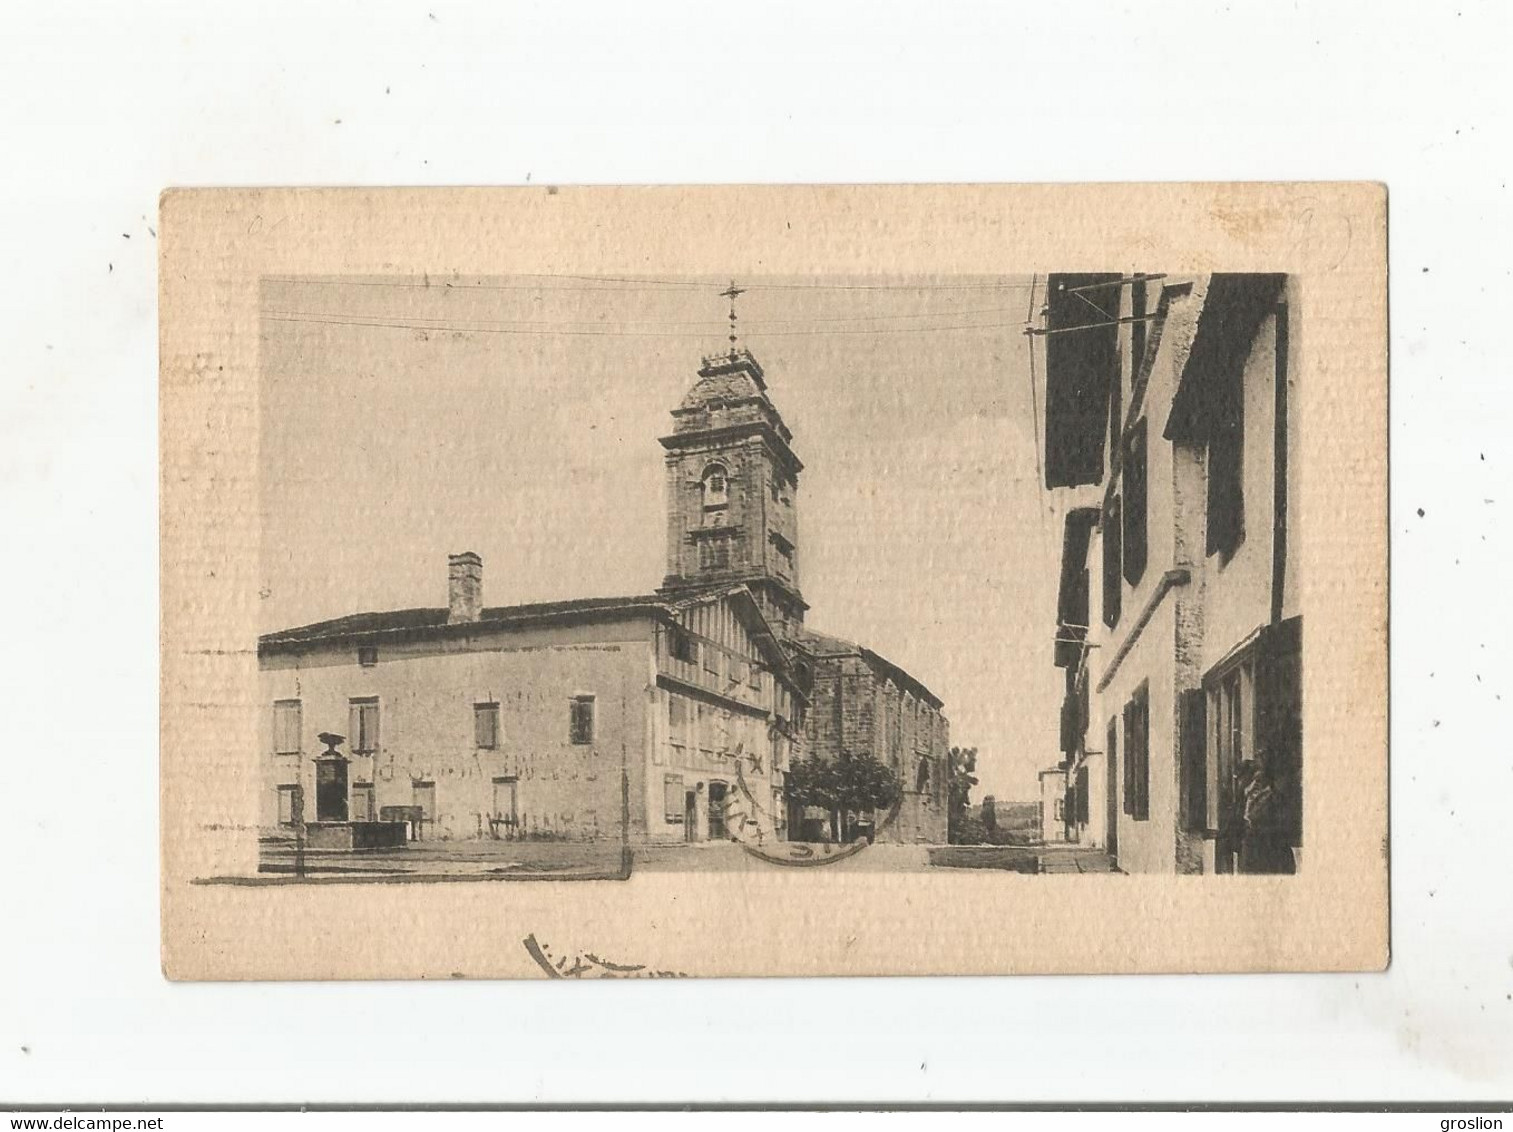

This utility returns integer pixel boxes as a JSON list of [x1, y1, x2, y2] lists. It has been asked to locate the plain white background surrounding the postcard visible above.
[[0, 0, 1513, 1105]]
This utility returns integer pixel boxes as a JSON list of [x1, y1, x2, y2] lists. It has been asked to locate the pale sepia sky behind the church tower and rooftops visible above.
[[260, 275, 1061, 801]]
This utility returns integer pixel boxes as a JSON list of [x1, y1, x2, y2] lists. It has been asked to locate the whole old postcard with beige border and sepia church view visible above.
[[160, 185, 1387, 979]]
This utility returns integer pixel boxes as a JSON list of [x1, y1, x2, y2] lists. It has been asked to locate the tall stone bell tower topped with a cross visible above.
[[660, 285, 808, 637]]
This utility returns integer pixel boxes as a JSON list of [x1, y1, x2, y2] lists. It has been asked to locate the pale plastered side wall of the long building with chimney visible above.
[[259, 624, 651, 838]]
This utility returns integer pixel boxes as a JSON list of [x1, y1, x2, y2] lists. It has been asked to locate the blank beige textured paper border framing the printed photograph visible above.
[[159, 183, 1389, 979]]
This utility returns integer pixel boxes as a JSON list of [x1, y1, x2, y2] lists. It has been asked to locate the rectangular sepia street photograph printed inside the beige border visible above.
[[245, 271, 1304, 881]]
